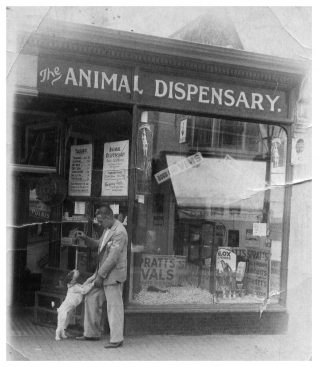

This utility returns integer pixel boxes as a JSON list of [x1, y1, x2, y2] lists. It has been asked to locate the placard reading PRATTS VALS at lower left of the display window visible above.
[[140, 254, 186, 288]]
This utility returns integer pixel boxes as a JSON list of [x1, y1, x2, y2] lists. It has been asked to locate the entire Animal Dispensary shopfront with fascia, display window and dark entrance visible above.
[[6, 19, 304, 333]]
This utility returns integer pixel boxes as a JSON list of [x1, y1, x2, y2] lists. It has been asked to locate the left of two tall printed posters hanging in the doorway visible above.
[[68, 144, 93, 196]]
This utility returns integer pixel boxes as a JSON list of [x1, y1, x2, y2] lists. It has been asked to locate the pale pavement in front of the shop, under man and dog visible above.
[[7, 312, 311, 361]]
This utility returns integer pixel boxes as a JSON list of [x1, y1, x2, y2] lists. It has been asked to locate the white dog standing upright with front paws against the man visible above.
[[55, 270, 94, 340]]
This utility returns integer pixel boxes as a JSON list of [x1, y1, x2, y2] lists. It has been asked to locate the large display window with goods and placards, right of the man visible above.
[[129, 111, 287, 306]]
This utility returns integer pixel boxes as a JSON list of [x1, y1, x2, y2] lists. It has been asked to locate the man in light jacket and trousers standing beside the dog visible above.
[[76, 206, 128, 348]]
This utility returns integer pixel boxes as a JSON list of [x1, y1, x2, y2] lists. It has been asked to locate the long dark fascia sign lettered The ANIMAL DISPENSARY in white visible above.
[[37, 57, 287, 118]]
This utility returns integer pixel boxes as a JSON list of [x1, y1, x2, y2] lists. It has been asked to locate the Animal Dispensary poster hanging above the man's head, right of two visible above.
[[102, 140, 129, 196]]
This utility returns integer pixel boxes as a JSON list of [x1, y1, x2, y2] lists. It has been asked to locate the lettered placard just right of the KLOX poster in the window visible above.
[[247, 248, 270, 298]]
